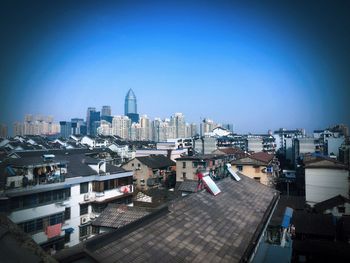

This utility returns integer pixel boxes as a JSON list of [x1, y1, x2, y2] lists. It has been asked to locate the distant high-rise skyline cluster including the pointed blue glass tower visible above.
[[14, 89, 206, 141]]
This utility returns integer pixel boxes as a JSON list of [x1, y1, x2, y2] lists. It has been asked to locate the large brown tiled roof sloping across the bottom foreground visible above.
[[80, 176, 278, 262]]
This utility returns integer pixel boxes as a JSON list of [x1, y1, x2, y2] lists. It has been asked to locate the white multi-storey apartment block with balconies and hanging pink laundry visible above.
[[0, 150, 133, 255]]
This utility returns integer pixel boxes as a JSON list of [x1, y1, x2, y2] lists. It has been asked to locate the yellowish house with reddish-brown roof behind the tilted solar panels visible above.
[[231, 152, 279, 186]]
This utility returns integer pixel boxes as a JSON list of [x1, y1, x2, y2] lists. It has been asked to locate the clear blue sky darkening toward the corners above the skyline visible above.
[[0, 1, 350, 132]]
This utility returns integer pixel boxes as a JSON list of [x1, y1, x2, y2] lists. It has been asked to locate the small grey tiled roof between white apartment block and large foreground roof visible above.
[[92, 204, 150, 228]]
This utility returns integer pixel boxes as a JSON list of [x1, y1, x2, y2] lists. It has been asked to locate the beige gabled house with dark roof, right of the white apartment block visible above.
[[122, 155, 175, 190]]
